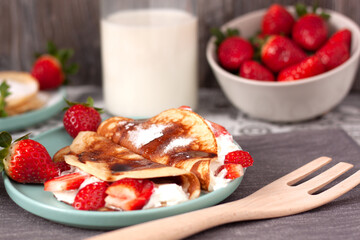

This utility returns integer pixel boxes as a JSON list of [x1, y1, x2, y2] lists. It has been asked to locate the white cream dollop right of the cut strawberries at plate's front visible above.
[[143, 183, 189, 209]]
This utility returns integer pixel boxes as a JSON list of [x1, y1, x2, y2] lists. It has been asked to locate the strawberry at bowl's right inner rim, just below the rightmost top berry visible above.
[[316, 42, 350, 71]]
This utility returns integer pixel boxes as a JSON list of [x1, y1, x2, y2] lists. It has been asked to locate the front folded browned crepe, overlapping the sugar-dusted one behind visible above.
[[54, 132, 200, 199]]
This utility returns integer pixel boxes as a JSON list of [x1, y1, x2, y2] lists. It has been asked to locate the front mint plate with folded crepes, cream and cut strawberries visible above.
[[3, 107, 252, 229]]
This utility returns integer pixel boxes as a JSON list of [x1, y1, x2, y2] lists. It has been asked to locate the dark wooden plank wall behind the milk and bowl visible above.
[[0, 0, 360, 90]]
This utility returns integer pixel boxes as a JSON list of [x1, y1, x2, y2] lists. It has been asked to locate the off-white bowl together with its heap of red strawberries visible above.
[[206, 4, 360, 122]]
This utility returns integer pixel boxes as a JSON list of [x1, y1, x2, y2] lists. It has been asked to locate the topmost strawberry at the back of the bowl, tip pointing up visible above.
[[261, 4, 295, 35]]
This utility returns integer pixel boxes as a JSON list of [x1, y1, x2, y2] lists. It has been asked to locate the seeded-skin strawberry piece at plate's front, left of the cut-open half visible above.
[[73, 182, 108, 210]]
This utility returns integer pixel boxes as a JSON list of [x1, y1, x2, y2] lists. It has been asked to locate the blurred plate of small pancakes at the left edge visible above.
[[0, 71, 66, 131]]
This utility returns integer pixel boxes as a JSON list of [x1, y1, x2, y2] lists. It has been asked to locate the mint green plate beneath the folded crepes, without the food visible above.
[[3, 127, 242, 229]]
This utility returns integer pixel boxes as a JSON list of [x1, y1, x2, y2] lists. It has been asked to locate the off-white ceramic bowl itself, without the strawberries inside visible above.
[[206, 8, 360, 122]]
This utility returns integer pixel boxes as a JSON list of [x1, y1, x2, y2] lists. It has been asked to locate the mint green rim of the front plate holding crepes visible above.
[[3, 126, 245, 229]]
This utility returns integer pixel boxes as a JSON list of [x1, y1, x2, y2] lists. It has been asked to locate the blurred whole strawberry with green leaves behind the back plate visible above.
[[31, 42, 78, 90]]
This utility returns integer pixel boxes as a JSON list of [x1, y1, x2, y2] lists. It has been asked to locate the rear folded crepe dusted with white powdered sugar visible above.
[[97, 109, 217, 190]]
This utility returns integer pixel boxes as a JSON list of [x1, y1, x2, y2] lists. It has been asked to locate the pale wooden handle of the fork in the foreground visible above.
[[87, 204, 245, 240]]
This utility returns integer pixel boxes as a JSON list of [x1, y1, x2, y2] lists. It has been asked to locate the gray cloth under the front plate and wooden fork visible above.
[[0, 129, 360, 240]]
